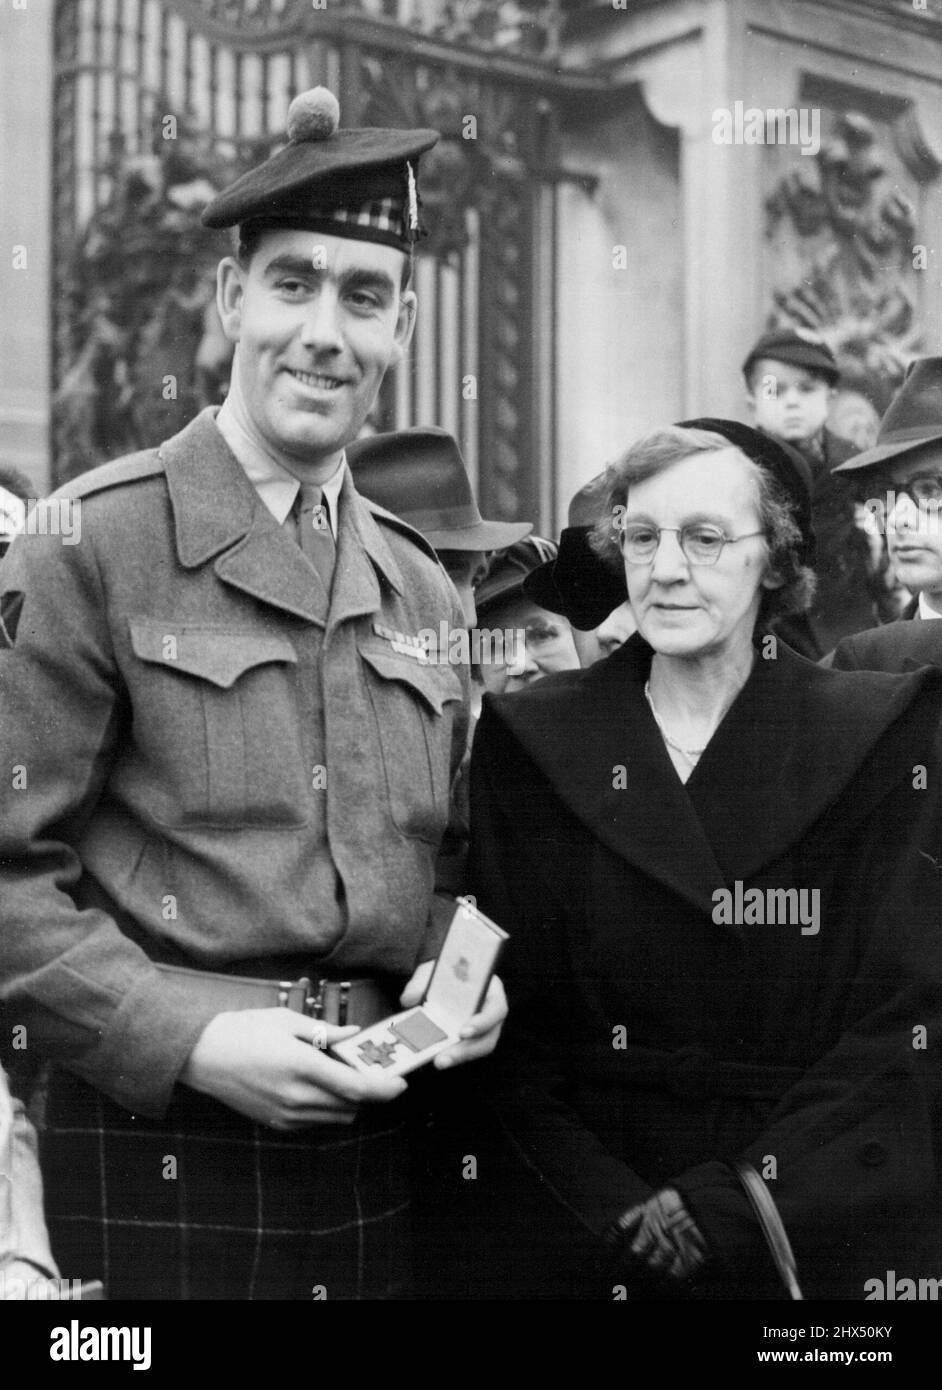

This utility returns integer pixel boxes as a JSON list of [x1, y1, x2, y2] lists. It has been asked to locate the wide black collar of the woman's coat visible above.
[[493, 635, 934, 913]]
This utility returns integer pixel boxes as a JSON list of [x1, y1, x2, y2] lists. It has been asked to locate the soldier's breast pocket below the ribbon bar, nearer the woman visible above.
[[360, 648, 464, 844]]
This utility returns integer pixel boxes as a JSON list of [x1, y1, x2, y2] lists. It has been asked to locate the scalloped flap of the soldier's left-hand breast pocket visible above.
[[128, 619, 297, 689]]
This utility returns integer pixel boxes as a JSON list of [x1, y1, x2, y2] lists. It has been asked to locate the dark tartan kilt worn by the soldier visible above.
[[40, 1068, 411, 1300]]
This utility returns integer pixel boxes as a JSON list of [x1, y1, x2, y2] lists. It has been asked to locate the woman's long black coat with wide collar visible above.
[[471, 635, 942, 1298]]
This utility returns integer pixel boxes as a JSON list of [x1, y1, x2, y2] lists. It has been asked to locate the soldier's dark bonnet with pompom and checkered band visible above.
[[203, 88, 438, 252]]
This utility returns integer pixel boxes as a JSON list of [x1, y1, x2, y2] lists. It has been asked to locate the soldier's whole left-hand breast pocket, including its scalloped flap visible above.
[[129, 619, 310, 828]]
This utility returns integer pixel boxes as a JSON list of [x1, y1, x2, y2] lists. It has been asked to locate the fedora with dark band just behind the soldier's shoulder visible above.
[[347, 428, 534, 550]]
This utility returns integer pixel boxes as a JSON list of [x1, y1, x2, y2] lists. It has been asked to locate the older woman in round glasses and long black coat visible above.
[[471, 420, 942, 1298]]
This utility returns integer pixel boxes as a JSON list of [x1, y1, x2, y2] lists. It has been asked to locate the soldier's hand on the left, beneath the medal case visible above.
[[181, 1008, 406, 1130]]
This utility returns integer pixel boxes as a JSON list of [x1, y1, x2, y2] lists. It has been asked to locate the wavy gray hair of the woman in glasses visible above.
[[590, 425, 816, 623]]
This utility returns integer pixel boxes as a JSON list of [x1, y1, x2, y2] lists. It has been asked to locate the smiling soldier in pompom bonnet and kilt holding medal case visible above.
[[0, 89, 506, 1300]]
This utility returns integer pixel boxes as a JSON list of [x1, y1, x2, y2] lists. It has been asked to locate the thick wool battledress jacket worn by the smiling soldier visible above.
[[0, 411, 467, 1115]]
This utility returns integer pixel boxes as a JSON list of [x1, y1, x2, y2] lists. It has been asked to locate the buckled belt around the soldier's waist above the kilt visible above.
[[157, 965, 399, 1029]]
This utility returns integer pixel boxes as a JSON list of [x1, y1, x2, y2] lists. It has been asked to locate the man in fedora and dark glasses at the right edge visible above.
[[832, 357, 942, 671]]
